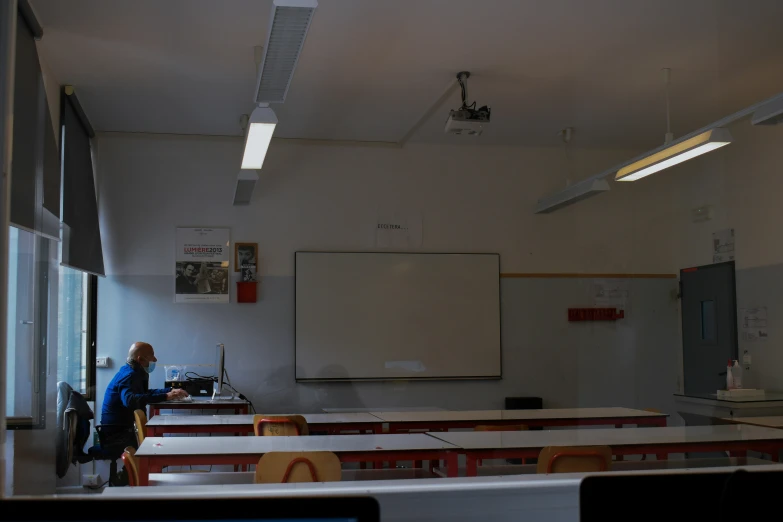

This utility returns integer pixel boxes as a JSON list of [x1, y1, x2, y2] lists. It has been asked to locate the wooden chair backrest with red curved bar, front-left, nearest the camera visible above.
[[255, 451, 342, 484]]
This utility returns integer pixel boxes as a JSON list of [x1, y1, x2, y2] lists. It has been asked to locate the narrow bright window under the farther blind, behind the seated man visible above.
[[57, 266, 95, 397]]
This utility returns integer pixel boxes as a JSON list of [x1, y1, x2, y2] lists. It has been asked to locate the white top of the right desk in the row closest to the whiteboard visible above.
[[373, 408, 667, 422]]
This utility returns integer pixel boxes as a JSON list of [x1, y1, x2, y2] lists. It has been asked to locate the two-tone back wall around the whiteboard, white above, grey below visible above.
[[92, 134, 678, 418]]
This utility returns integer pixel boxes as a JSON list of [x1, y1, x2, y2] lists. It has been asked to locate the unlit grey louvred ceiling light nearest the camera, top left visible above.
[[256, 0, 318, 103]]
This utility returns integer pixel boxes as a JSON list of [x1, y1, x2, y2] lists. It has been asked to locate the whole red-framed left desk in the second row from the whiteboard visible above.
[[136, 433, 459, 486]]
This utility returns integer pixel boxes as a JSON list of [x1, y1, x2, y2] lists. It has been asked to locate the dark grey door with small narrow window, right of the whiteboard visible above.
[[680, 261, 737, 395]]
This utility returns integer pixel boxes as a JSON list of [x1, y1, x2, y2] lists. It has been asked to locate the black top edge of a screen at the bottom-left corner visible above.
[[2, 497, 380, 522]]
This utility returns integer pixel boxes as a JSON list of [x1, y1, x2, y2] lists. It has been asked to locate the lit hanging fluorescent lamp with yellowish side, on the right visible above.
[[615, 128, 731, 181]]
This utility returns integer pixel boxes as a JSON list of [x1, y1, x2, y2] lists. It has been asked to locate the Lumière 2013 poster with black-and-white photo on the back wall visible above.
[[174, 228, 231, 303]]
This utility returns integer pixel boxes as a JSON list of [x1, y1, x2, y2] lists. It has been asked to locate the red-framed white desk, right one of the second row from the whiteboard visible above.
[[429, 425, 783, 477]]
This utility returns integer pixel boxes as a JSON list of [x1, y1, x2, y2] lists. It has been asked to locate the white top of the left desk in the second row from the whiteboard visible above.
[[136, 430, 460, 457]]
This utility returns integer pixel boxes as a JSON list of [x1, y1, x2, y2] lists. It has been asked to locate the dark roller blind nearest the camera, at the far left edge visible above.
[[10, 10, 60, 239]]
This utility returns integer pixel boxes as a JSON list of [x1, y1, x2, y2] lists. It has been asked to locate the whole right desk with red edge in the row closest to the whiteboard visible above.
[[372, 408, 668, 433]]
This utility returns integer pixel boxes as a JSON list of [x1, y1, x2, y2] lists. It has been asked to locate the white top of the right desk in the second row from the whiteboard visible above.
[[428, 424, 783, 450]]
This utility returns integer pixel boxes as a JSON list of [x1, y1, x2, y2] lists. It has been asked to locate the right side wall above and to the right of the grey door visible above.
[[634, 119, 783, 390]]
